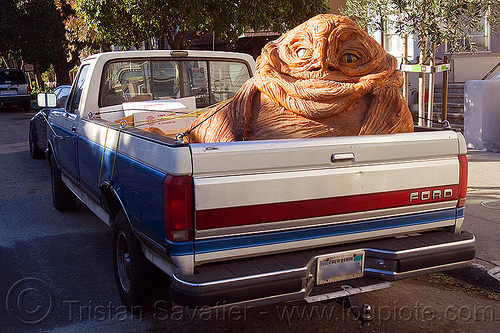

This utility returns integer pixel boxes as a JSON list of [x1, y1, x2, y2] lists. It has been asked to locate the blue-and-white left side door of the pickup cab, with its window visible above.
[[52, 65, 89, 181]]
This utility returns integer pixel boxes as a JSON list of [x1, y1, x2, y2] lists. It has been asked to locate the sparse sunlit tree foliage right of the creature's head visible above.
[[342, 0, 500, 64]]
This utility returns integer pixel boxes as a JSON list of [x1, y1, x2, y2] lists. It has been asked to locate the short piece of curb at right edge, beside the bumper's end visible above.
[[447, 258, 500, 292]]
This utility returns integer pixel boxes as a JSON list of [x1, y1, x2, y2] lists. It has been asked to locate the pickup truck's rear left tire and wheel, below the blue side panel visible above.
[[113, 211, 149, 310]]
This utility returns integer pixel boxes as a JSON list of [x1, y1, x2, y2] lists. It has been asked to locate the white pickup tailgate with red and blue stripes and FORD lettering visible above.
[[191, 131, 466, 264]]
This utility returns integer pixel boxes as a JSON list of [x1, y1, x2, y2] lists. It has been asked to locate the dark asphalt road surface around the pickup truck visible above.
[[0, 110, 500, 333]]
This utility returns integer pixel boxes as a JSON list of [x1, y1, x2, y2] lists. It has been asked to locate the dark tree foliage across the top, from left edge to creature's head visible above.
[[0, 0, 328, 84]]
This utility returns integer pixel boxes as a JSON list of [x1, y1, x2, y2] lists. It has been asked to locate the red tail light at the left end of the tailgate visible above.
[[163, 175, 194, 242]]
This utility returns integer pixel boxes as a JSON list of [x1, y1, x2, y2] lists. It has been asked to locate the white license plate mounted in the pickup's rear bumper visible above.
[[316, 250, 365, 284]]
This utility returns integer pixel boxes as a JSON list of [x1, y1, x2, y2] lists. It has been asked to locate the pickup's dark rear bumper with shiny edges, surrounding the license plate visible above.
[[171, 231, 476, 307]]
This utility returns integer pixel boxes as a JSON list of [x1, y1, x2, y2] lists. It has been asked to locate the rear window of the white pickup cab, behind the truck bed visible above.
[[99, 59, 250, 108]]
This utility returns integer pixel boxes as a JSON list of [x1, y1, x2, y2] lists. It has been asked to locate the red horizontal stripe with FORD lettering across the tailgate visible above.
[[196, 184, 459, 230]]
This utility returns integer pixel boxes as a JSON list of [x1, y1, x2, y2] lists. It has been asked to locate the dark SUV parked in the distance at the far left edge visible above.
[[0, 68, 31, 111]]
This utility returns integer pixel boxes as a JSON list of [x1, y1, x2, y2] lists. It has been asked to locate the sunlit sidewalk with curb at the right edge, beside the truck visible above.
[[451, 150, 500, 291]]
